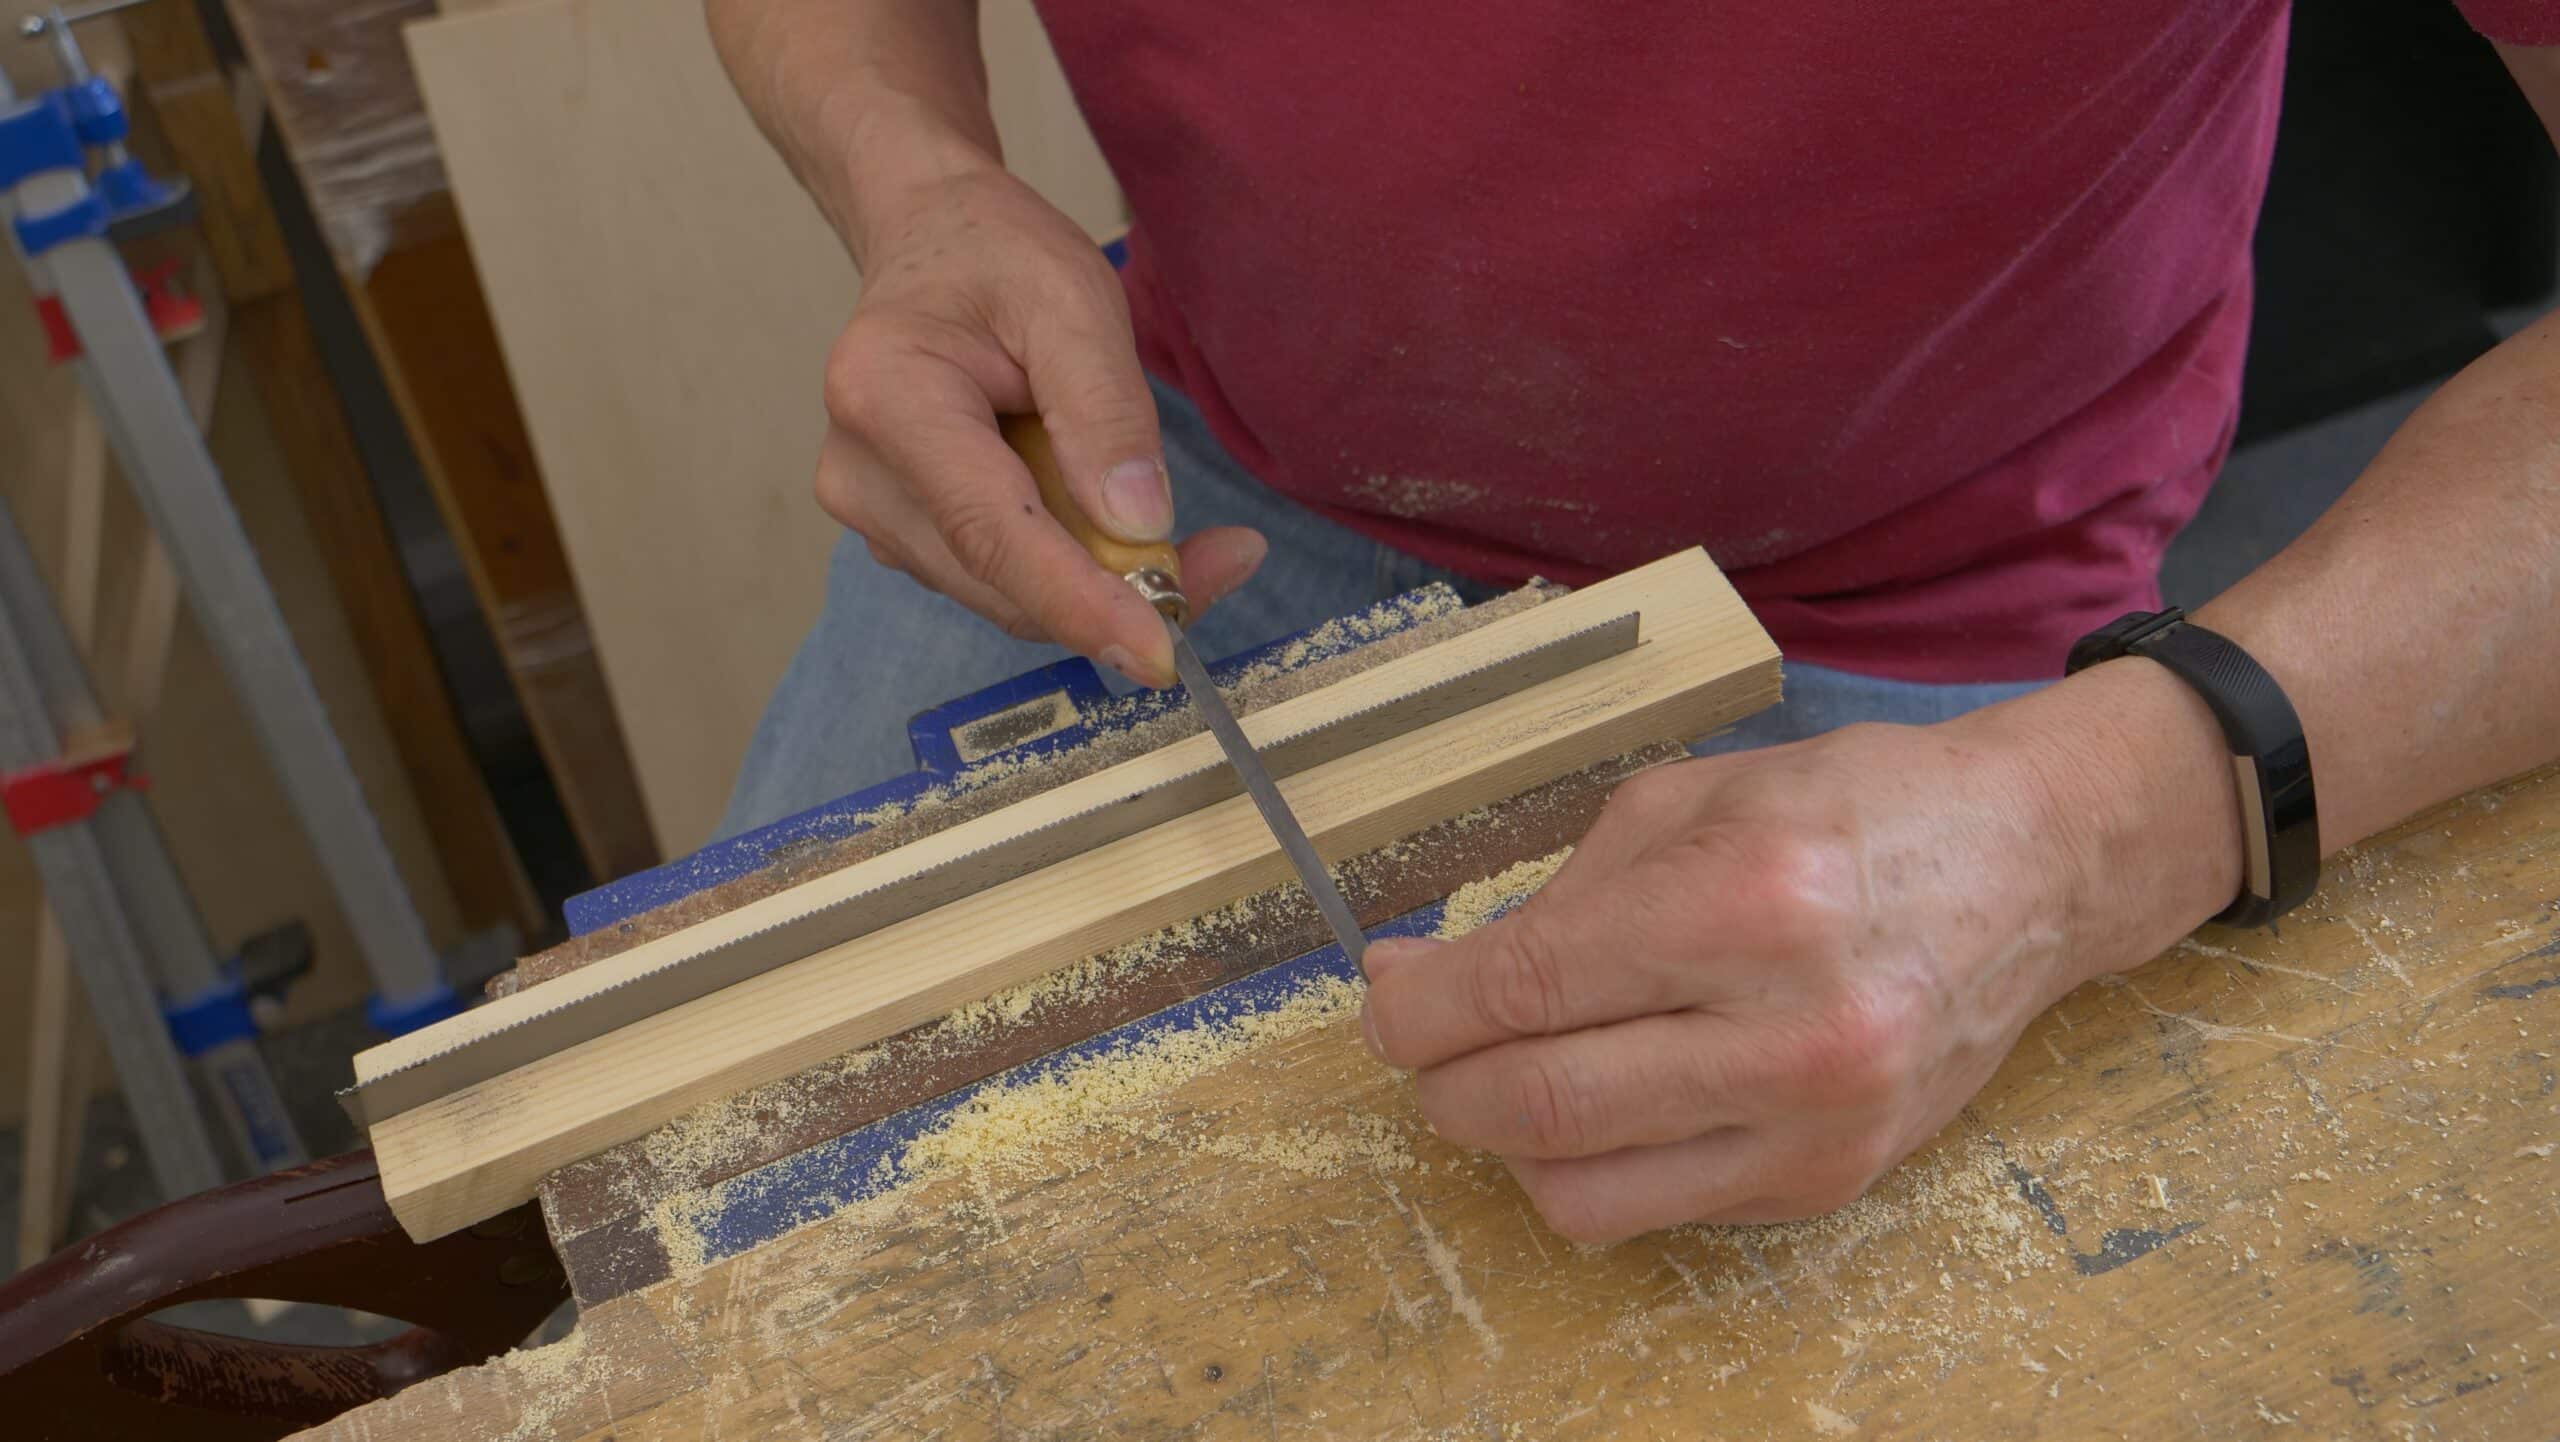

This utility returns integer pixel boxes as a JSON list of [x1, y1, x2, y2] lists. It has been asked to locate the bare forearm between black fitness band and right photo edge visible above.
[[2196, 312, 2560, 853]]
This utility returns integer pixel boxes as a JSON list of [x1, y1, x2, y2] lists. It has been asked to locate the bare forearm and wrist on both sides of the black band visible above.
[[1951, 318, 2560, 984]]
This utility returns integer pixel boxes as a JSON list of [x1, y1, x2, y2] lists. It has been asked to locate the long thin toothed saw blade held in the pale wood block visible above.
[[338, 612, 1638, 1127]]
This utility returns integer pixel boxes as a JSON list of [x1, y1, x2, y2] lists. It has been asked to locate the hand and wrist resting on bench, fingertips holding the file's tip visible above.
[[1364, 661, 2240, 1242]]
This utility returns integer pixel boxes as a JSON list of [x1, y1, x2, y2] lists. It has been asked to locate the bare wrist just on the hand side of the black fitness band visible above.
[[1964, 656, 2245, 984]]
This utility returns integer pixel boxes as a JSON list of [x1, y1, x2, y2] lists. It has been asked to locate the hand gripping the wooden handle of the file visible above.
[[817, 169, 1265, 686]]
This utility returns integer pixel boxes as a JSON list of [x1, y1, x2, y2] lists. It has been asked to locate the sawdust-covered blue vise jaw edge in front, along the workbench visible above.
[[668, 902, 1484, 1263]]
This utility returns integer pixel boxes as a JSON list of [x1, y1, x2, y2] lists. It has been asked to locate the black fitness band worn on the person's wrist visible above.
[[2063, 607, 2319, 927]]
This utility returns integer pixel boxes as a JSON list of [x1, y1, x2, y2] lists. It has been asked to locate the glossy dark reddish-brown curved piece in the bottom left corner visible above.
[[0, 1153, 568, 1442]]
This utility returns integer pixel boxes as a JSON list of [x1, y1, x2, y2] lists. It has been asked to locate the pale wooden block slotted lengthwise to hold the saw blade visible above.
[[356, 551, 1777, 1240]]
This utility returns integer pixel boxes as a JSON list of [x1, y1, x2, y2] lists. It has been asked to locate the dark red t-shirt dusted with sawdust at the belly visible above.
[[1039, 0, 2560, 681]]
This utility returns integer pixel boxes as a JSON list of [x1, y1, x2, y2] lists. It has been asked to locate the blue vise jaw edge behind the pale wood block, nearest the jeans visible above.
[[561, 581, 1459, 937]]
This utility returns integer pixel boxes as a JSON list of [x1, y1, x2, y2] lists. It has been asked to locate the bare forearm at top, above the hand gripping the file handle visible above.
[[704, 0, 1004, 266]]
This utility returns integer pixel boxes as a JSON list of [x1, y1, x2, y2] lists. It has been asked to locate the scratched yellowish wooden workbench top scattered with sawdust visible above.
[[304, 771, 2560, 1442]]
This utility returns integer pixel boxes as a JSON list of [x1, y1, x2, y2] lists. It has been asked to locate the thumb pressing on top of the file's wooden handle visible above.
[[1024, 315, 1172, 540]]
